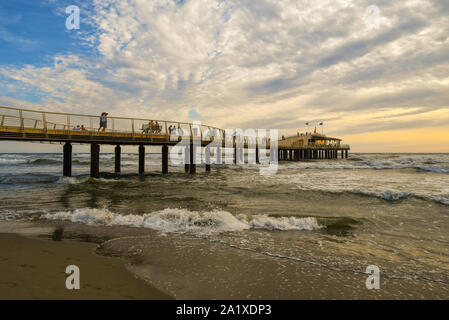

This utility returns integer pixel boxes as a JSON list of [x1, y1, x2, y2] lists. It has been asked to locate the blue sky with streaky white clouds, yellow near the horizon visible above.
[[0, 0, 449, 152]]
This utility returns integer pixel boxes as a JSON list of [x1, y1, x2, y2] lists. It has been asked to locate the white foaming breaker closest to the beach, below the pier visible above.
[[41, 208, 323, 234]]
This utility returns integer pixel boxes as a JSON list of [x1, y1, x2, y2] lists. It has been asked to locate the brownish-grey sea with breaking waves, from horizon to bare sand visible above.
[[0, 150, 449, 299]]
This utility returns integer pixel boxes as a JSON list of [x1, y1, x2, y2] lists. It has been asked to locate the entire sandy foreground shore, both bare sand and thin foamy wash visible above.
[[0, 222, 449, 300]]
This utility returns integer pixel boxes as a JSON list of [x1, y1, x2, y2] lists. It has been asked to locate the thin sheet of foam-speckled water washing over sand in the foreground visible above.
[[98, 234, 449, 300]]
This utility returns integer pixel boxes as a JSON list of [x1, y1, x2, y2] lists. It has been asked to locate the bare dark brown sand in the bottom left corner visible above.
[[0, 233, 170, 300]]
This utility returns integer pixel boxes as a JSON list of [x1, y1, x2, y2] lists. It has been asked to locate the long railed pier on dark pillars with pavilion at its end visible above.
[[0, 106, 350, 178]]
